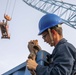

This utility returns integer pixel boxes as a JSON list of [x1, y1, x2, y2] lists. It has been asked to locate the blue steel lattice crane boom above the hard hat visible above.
[[23, 0, 76, 29]]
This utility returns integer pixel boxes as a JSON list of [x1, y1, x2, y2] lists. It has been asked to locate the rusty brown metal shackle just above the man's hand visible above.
[[28, 40, 41, 60]]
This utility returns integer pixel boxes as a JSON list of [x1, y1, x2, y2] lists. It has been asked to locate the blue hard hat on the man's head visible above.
[[38, 14, 63, 35]]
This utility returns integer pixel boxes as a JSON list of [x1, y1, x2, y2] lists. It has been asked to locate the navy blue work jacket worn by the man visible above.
[[36, 38, 76, 75]]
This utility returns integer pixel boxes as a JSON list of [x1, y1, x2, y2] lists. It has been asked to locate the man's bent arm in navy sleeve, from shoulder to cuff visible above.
[[36, 45, 74, 75]]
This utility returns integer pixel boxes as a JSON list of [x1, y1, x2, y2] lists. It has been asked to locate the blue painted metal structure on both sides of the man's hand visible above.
[[2, 50, 50, 75]]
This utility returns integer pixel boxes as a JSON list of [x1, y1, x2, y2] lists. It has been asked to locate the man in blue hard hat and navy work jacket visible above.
[[27, 14, 76, 75]]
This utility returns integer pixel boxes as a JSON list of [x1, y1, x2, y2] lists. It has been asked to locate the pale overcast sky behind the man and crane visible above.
[[0, 0, 76, 75]]
